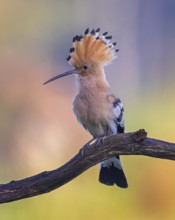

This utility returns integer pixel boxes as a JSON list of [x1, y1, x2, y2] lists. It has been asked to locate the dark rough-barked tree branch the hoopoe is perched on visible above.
[[0, 130, 175, 203]]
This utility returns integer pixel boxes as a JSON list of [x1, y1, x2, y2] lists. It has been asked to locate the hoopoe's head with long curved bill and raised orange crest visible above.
[[44, 28, 119, 84]]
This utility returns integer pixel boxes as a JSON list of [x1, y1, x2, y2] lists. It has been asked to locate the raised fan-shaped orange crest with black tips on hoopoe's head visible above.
[[67, 28, 119, 68]]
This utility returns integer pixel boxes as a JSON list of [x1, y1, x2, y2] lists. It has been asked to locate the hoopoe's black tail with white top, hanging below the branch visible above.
[[99, 155, 128, 188]]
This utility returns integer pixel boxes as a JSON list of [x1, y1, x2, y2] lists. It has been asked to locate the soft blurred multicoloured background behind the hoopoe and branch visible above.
[[0, 0, 175, 220]]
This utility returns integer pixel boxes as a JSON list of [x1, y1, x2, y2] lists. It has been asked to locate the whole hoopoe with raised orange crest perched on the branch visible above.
[[44, 28, 128, 188]]
